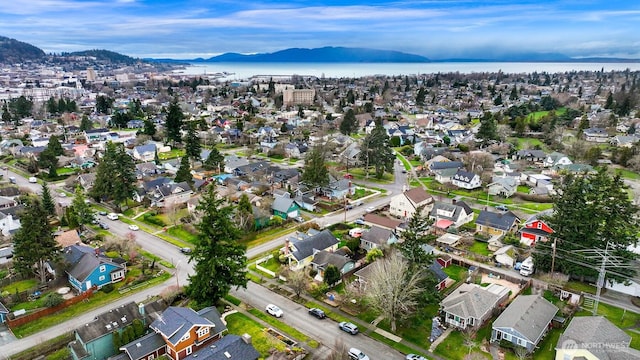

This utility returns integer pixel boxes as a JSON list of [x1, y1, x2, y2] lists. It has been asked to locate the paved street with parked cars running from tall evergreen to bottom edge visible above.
[[232, 282, 404, 360]]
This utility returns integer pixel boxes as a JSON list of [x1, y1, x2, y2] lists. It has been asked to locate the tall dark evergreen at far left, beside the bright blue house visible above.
[[13, 199, 60, 284]]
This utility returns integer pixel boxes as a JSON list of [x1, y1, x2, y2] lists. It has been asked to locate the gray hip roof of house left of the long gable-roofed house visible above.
[[440, 283, 504, 319]]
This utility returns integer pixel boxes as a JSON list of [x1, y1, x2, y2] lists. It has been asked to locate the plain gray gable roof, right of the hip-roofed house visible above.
[[493, 295, 558, 344]]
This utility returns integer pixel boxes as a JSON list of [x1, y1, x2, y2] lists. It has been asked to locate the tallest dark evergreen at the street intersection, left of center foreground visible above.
[[186, 184, 247, 306]]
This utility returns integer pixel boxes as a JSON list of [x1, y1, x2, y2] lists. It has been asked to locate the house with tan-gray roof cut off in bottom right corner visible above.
[[555, 316, 640, 360]]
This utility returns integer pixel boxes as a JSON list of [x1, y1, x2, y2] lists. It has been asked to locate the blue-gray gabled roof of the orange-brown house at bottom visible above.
[[149, 306, 218, 345]]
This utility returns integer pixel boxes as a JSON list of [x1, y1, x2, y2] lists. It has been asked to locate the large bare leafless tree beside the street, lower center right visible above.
[[366, 252, 424, 332]]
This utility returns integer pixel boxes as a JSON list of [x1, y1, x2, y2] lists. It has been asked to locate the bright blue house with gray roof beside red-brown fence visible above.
[[65, 245, 127, 292]]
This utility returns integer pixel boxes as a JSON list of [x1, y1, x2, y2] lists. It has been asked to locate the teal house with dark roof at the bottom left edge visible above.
[[68, 302, 145, 360]]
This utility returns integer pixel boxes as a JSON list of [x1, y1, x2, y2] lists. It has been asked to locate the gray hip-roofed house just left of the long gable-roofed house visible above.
[[440, 283, 509, 330]]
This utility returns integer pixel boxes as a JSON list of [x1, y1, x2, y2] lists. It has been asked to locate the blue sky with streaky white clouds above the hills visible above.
[[0, 0, 640, 59]]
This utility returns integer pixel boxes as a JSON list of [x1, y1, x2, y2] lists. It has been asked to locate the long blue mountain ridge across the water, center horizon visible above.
[[198, 46, 430, 63]]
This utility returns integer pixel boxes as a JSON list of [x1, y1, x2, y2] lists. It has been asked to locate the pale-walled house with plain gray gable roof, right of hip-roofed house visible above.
[[491, 295, 558, 352]]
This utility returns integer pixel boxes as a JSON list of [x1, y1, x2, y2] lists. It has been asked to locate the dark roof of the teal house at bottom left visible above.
[[75, 301, 143, 344]]
